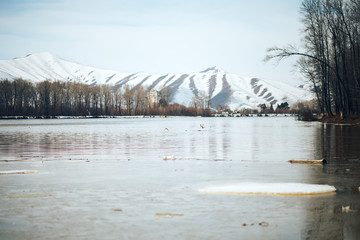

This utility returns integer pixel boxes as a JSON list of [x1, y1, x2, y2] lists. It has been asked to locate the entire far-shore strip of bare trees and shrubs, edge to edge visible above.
[[0, 78, 360, 124]]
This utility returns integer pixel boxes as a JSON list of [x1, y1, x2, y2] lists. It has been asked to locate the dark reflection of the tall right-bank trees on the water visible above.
[[304, 124, 360, 239]]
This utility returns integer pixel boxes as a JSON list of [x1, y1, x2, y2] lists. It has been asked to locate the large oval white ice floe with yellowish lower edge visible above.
[[199, 182, 336, 196]]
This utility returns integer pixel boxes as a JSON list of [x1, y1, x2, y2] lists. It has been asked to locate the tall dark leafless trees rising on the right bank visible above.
[[266, 0, 360, 116]]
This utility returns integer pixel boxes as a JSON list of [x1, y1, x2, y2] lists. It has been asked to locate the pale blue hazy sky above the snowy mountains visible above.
[[0, 0, 302, 84]]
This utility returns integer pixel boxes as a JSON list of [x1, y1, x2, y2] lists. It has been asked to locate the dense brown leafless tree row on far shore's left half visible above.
[[0, 79, 210, 116]]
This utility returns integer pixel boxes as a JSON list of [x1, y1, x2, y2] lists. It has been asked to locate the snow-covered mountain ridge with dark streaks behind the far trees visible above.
[[0, 52, 314, 109]]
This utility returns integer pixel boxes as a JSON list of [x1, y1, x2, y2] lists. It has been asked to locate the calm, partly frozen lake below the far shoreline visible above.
[[0, 117, 360, 239]]
